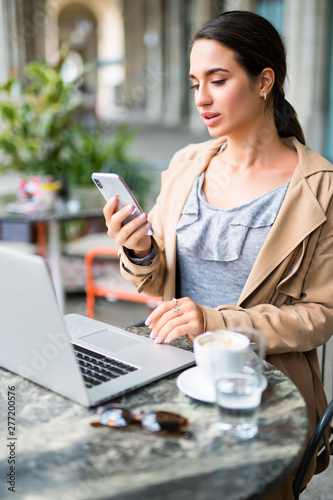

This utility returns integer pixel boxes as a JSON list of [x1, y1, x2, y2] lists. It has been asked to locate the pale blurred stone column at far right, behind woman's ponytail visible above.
[[284, 0, 330, 152]]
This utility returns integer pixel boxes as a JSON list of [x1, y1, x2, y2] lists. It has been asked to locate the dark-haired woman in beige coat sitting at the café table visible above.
[[104, 11, 333, 499]]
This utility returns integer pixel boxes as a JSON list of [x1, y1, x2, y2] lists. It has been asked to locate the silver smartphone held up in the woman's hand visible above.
[[91, 172, 154, 236]]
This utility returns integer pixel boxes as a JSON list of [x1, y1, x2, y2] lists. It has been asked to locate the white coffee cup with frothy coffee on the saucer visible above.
[[193, 330, 250, 382]]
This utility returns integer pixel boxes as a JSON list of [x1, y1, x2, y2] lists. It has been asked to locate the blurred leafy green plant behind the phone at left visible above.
[[0, 46, 148, 193]]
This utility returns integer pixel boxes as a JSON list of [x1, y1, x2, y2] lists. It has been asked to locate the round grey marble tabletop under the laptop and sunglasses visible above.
[[0, 328, 308, 500]]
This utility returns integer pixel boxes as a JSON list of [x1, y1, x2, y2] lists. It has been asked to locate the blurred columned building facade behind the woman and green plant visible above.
[[0, 0, 333, 156]]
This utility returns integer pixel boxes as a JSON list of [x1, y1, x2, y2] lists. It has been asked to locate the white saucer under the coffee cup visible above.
[[176, 366, 267, 403]]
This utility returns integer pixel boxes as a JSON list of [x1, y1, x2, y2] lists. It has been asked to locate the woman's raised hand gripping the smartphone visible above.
[[103, 195, 151, 258]]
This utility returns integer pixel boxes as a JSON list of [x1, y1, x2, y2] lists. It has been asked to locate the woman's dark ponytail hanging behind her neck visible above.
[[274, 91, 305, 145]]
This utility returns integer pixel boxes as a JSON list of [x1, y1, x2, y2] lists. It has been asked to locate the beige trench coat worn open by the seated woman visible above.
[[119, 138, 333, 488]]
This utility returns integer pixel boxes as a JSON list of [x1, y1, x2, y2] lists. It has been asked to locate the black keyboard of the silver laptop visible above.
[[73, 344, 138, 388]]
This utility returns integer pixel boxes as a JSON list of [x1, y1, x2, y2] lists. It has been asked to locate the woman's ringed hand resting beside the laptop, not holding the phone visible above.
[[145, 297, 204, 344]]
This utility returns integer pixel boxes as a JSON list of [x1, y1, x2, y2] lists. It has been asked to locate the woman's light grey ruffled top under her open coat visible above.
[[176, 173, 289, 307]]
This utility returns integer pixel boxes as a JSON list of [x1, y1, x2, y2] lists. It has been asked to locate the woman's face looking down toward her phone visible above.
[[189, 39, 263, 137]]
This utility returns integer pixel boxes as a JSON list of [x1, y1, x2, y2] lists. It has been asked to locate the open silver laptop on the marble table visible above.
[[0, 248, 195, 407]]
